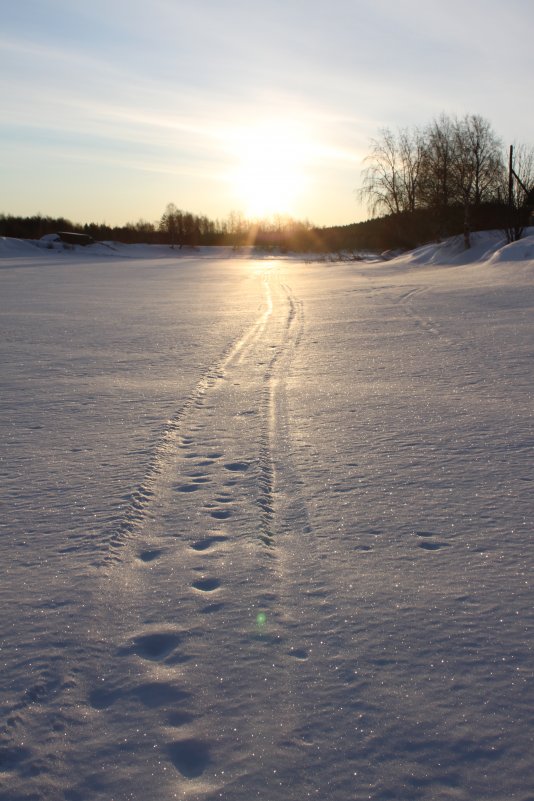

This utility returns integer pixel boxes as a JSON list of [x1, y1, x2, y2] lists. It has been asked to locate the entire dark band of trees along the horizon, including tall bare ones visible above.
[[0, 115, 534, 255]]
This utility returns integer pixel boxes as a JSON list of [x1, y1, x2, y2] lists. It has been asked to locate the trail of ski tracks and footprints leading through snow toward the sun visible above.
[[59, 268, 310, 799]]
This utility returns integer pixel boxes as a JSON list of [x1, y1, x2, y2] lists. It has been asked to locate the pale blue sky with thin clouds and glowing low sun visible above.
[[0, 0, 534, 225]]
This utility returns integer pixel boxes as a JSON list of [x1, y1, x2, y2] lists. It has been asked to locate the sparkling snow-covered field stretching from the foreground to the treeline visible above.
[[0, 235, 534, 801]]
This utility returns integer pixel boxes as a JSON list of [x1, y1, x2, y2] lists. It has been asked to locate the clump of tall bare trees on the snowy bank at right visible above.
[[359, 114, 534, 247]]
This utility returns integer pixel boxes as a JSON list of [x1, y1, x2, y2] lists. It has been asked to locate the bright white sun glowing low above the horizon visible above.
[[231, 121, 307, 218]]
